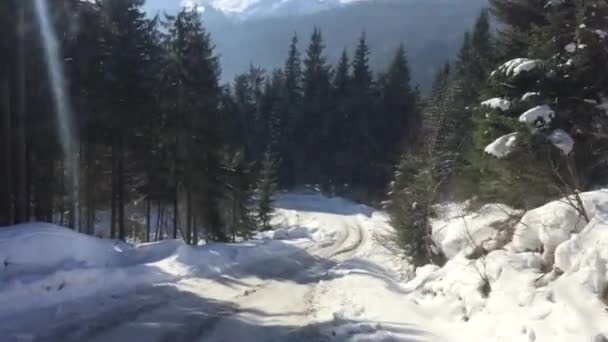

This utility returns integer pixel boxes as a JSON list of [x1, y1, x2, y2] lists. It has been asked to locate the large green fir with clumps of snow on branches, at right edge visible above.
[[476, 1, 608, 207]]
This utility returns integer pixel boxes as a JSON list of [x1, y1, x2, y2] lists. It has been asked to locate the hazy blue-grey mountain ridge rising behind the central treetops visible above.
[[146, 0, 487, 89]]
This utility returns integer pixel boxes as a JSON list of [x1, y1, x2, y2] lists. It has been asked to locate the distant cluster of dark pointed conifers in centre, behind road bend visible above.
[[228, 29, 420, 199]]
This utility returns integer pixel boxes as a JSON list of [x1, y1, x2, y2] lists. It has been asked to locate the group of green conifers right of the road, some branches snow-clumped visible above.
[[385, 0, 608, 264]]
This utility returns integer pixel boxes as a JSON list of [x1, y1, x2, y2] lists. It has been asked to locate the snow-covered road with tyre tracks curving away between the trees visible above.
[[0, 194, 438, 341]]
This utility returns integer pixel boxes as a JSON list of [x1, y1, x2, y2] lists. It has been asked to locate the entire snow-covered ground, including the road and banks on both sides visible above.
[[0, 190, 608, 342]]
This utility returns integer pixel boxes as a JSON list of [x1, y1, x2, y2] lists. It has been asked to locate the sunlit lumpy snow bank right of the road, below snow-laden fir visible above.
[[403, 190, 608, 342]]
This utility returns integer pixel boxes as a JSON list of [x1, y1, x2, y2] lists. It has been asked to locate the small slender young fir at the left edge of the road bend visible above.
[[256, 152, 277, 230]]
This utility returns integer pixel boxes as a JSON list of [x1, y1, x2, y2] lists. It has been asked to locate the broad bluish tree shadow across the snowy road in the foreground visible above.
[[0, 285, 430, 342]]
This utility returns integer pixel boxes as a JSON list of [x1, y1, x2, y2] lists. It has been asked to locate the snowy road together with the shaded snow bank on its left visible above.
[[0, 193, 441, 341]]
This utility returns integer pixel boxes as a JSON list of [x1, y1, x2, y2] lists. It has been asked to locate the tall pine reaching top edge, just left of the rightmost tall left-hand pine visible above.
[[98, 0, 156, 240]]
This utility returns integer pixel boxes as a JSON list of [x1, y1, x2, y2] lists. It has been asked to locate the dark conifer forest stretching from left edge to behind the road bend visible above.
[[0, 0, 421, 244]]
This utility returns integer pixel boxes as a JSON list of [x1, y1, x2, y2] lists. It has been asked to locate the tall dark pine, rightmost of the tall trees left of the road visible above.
[[164, 10, 227, 243]]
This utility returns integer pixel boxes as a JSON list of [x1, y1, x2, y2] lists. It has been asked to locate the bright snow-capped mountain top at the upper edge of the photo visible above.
[[146, 0, 364, 19]]
